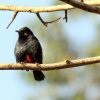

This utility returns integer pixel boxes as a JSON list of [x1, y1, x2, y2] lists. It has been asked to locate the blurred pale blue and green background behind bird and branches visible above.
[[0, 0, 100, 100]]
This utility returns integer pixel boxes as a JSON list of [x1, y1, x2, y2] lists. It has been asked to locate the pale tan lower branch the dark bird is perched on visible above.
[[0, 56, 100, 71]]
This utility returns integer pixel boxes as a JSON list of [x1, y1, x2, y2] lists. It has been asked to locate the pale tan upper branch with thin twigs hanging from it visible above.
[[0, 0, 100, 14]]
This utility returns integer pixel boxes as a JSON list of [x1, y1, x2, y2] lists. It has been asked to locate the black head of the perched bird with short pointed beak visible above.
[[16, 27, 33, 38]]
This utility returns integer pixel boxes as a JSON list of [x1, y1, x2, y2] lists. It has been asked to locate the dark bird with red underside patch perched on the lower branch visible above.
[[14, 27, 45, 81]]
